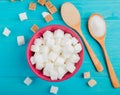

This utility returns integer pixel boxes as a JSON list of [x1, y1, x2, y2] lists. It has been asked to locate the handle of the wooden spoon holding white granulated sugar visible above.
[[101, 44, 120, 88]]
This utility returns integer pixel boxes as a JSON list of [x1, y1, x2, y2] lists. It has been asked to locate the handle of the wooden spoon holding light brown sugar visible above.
[[76, 29, 103, 72]]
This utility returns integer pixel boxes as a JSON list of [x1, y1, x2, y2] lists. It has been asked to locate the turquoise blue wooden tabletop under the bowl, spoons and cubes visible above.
[[0, 0, 120, 95]]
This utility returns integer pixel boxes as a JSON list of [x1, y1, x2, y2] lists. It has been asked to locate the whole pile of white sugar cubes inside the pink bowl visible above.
[[30, 29, 82, 80]]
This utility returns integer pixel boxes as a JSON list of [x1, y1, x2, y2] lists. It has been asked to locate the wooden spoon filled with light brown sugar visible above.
[[61, 2, 103, 72]]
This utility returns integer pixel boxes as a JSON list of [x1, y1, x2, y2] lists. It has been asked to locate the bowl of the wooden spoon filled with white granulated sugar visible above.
[[88, 14, 106, 43]]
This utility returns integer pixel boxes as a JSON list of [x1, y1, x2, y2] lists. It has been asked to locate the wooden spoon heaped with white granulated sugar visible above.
[[88, 14, 120, 88]]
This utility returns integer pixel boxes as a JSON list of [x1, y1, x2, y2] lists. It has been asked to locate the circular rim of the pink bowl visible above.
[[26, 24, 84, 82]]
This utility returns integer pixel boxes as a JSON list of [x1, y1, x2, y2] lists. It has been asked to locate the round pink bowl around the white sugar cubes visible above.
[[27, 25, 84, 82]]
